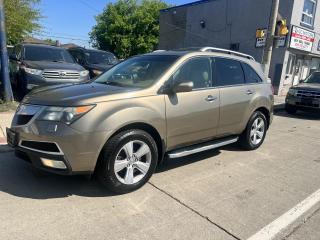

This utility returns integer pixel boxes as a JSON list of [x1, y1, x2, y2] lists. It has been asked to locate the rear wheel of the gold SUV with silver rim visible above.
[[239, 111, 268, 150]]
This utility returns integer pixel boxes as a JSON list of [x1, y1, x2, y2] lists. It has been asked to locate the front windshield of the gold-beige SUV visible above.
[[95, 55, 179, 88]]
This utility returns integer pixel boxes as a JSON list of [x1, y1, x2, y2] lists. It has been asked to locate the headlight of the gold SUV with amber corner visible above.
[[38, 105, 95, 124]]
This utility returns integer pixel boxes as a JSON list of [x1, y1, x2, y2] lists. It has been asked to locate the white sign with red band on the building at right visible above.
[[290, 26, 315, 52]]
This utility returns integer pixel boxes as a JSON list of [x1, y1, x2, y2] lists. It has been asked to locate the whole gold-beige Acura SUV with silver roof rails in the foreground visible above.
[[7, 48, 273, 193]]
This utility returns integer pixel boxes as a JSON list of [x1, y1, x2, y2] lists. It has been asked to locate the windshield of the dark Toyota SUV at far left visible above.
[[24, 46, 74, 63]]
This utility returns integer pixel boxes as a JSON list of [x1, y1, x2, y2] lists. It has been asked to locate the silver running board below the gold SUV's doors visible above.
[[168, 137, 239, 158]]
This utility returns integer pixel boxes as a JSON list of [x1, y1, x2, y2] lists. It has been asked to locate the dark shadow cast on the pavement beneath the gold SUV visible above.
[[0, 146, 220, 199]]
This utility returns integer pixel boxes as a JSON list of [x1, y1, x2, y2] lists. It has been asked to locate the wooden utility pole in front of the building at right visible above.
[[262, 0, 279, 77]]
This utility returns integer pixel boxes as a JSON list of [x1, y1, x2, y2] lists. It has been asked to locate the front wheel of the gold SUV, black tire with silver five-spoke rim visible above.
[[97, 129, 158, 194]]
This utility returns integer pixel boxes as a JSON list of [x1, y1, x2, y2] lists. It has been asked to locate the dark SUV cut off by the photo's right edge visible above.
[[285, 71, 320, 114]]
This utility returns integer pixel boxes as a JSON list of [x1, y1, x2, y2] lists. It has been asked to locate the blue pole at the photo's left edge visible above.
[[0, 0, 13, 102]]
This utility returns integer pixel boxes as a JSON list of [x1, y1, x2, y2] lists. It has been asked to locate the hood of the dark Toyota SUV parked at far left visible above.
[[24, 61, 84, 71]]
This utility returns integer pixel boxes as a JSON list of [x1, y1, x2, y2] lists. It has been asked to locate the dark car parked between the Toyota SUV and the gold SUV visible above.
[[68, 47, 119, 78]]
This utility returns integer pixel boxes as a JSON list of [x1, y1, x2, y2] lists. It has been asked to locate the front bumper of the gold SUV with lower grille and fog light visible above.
[[7, 112, 110, 175]]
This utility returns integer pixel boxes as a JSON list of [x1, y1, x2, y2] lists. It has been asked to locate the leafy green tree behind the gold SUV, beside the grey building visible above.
[[90, 0, 169, 58]]
